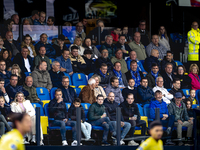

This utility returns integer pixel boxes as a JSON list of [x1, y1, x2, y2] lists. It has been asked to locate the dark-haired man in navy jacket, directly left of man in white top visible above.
[[136, 77, 154, 106]]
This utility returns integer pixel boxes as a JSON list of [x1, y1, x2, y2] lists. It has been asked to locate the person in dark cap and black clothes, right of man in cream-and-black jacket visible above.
[[83, 49, 96, 75]]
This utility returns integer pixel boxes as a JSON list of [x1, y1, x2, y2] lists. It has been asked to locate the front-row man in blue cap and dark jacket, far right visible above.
[[168, 92, 193, 146]]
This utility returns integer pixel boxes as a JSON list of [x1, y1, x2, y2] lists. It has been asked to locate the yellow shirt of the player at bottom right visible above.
[[137, 137, 163, 150]]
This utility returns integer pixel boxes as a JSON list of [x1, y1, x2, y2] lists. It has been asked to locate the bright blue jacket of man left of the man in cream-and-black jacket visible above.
[[56, 55, 73, 73]]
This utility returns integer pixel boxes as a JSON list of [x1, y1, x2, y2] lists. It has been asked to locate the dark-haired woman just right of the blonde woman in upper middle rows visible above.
[[83, 37, 101, 59]]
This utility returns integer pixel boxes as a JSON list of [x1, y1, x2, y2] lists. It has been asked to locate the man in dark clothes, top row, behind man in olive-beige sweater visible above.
[[134, 20, 149, 46]]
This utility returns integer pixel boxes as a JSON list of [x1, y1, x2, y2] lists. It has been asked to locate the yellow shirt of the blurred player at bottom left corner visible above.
[[0, 129, 25, 150]]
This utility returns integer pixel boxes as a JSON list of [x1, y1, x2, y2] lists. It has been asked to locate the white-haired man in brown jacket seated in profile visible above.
[[79, 78, 96, 104]]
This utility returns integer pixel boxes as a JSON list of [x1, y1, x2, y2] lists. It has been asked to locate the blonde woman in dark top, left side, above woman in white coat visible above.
[[11, 64, 26, 85]]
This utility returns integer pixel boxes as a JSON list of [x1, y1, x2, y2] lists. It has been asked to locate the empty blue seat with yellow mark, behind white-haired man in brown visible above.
[[72, 73, 87, 87]]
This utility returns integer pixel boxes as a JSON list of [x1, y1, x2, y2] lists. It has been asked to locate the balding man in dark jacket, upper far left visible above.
[[4, 31, 21, 57]]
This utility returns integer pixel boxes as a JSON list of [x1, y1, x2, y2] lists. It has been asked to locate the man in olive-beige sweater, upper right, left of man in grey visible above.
[[128, 32, 147, 60]]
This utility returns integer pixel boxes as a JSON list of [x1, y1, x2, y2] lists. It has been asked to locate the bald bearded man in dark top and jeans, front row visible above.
[[103, 92, 131, 145]]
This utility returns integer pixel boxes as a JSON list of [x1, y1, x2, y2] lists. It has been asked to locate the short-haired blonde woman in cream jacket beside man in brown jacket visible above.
[[91, 74, 107, 99]]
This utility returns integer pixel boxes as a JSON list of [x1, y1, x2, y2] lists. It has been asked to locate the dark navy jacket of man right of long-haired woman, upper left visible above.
[[35, 41, 56, 58]]
